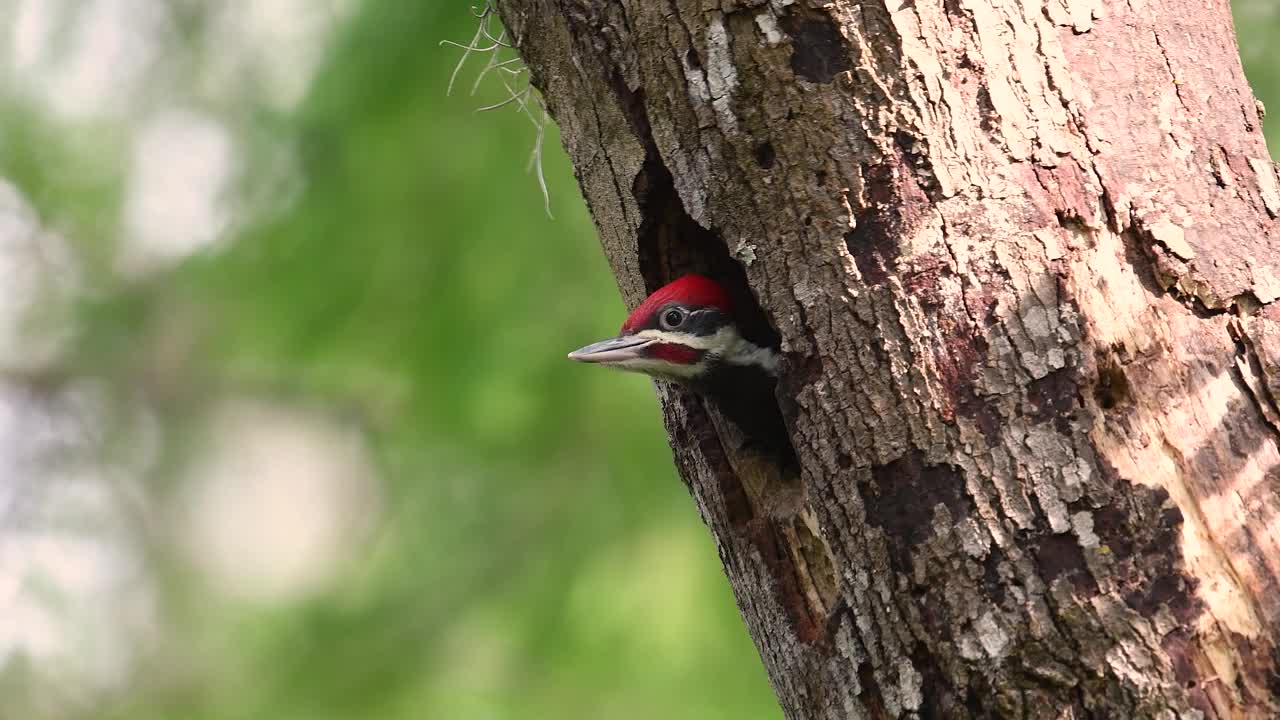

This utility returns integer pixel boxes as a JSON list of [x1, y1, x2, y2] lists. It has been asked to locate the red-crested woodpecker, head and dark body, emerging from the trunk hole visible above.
[[568, 274, 795, 466]]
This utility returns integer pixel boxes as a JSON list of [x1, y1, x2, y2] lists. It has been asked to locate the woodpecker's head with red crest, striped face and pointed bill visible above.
[[568, 275, 778, 382]]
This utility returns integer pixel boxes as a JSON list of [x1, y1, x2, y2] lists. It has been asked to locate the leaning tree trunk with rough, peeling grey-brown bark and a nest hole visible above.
[[499, 0, 1280, 719]]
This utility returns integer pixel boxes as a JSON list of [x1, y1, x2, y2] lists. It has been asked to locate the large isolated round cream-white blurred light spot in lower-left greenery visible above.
[[173, 400, 380, 602]]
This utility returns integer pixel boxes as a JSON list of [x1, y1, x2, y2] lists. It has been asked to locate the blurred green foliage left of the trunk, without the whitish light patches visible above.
[[0, 0, 1280, 720]]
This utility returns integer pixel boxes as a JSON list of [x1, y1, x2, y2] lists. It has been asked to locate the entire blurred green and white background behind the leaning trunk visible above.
[[0, 0, 1280, 720]]
